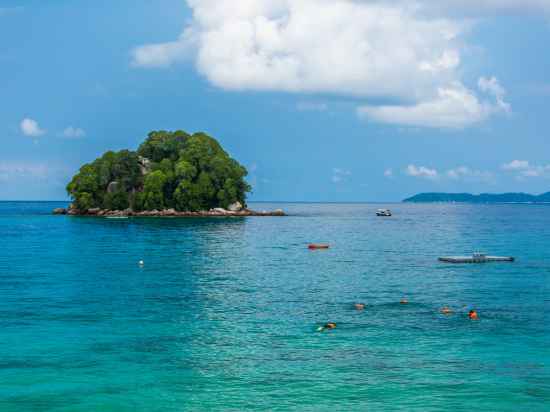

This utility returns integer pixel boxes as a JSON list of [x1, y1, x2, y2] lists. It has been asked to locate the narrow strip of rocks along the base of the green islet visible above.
[[53, 207, 286, 217]]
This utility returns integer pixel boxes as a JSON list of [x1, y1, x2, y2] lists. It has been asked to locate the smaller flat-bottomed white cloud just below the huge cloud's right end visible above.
[[357, 77, 510, 128]]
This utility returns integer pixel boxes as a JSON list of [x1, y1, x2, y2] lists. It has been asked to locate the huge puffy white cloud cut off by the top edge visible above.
[[133, 0, 464, 99]]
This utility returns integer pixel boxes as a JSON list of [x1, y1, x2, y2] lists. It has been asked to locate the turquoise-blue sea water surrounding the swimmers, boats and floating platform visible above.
[[0, 202, 550, 412]]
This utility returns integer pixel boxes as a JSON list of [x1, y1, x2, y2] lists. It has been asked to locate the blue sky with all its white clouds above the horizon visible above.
[[0, 0, 550, 202]]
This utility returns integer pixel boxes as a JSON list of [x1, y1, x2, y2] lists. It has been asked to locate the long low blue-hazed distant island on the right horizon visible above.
[[403, 192, 550, 203]]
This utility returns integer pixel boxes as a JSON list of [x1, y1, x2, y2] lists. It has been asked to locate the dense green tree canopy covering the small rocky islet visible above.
[[67, 131, 250, 211]]
